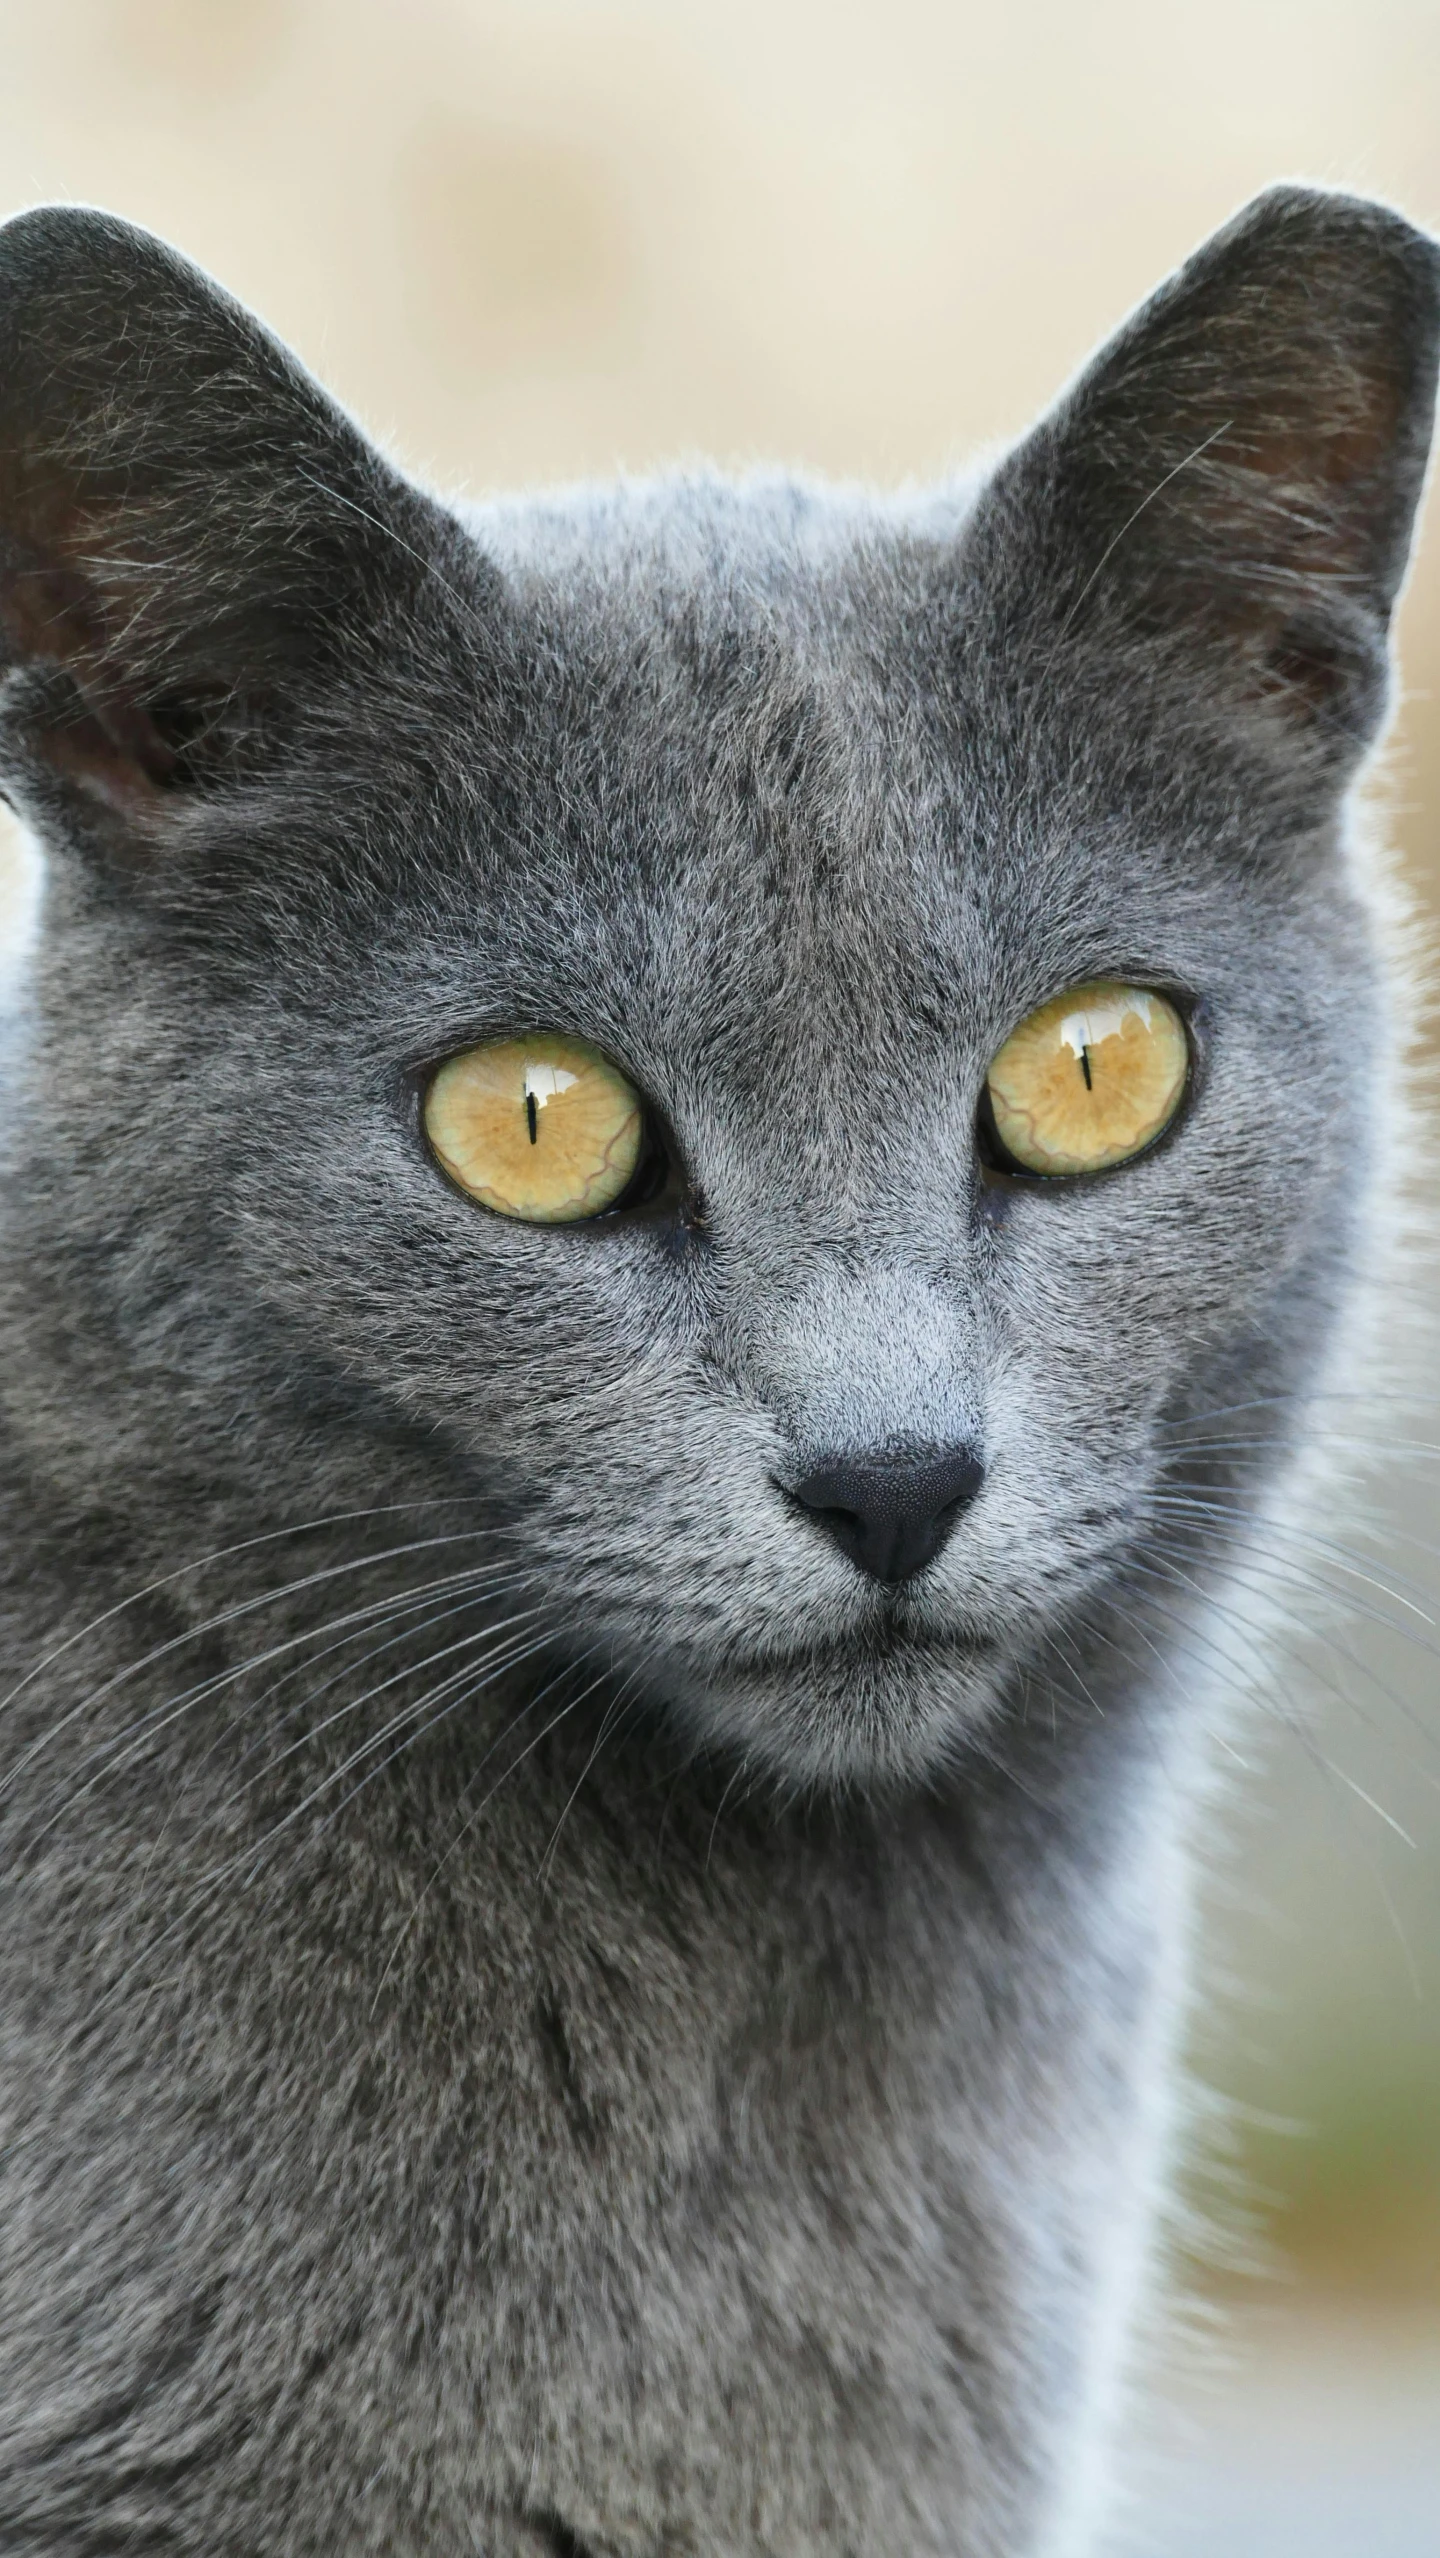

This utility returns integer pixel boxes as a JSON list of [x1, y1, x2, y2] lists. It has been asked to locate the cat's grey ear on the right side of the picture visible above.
[[977, 187, 1440, 762]]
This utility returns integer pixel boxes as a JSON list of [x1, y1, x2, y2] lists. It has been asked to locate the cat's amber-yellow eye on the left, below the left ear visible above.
[[425, 1031, 645, 1225]]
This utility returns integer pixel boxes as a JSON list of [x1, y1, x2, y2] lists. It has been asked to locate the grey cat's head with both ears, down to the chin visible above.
[[0, 189, 1440, 1780]]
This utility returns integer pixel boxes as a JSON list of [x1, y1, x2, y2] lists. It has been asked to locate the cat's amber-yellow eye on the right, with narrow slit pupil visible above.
[[987, 980, 1189, 1174]]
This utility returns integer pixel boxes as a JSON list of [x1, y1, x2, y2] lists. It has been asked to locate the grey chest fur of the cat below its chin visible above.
[[8, 1555, 1164, 2553]]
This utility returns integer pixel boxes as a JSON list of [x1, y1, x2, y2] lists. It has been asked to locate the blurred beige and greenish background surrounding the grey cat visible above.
[[0, 0, 1440, 2558]]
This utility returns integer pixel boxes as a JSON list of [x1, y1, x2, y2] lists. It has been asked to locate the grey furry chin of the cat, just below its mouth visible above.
[[659, 1637, 1008, 1791]]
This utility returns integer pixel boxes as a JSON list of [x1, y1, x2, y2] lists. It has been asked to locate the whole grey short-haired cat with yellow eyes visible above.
[[0, 187, 1440, 2558]]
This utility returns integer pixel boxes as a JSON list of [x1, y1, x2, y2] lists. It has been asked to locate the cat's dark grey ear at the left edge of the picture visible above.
[[0, 207, 445, 831]]
